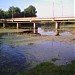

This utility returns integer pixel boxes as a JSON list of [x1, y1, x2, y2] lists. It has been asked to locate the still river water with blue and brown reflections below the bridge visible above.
[[0, 30, 75, 75]]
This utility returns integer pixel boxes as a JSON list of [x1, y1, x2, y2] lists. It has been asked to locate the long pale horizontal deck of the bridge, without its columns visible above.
[[0, 17, 75, 22]]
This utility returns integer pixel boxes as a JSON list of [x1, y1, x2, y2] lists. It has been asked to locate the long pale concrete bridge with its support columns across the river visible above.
[[0, 17, 75, 35]]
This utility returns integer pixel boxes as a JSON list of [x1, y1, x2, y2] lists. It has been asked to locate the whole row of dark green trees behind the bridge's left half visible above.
[[0, 5, 37, 19]]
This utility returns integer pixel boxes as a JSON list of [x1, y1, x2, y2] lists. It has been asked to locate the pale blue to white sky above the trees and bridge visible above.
[[0, 0, 75, 17]]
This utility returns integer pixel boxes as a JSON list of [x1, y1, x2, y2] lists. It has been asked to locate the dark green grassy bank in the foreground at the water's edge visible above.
[[17, 61, 75, 75]]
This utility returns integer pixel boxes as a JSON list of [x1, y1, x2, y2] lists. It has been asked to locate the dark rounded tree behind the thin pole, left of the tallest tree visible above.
[[8, 6, 21, 18]]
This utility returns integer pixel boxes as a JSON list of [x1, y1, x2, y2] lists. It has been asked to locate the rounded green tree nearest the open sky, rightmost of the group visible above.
[[23, 5, 37, 17]]
